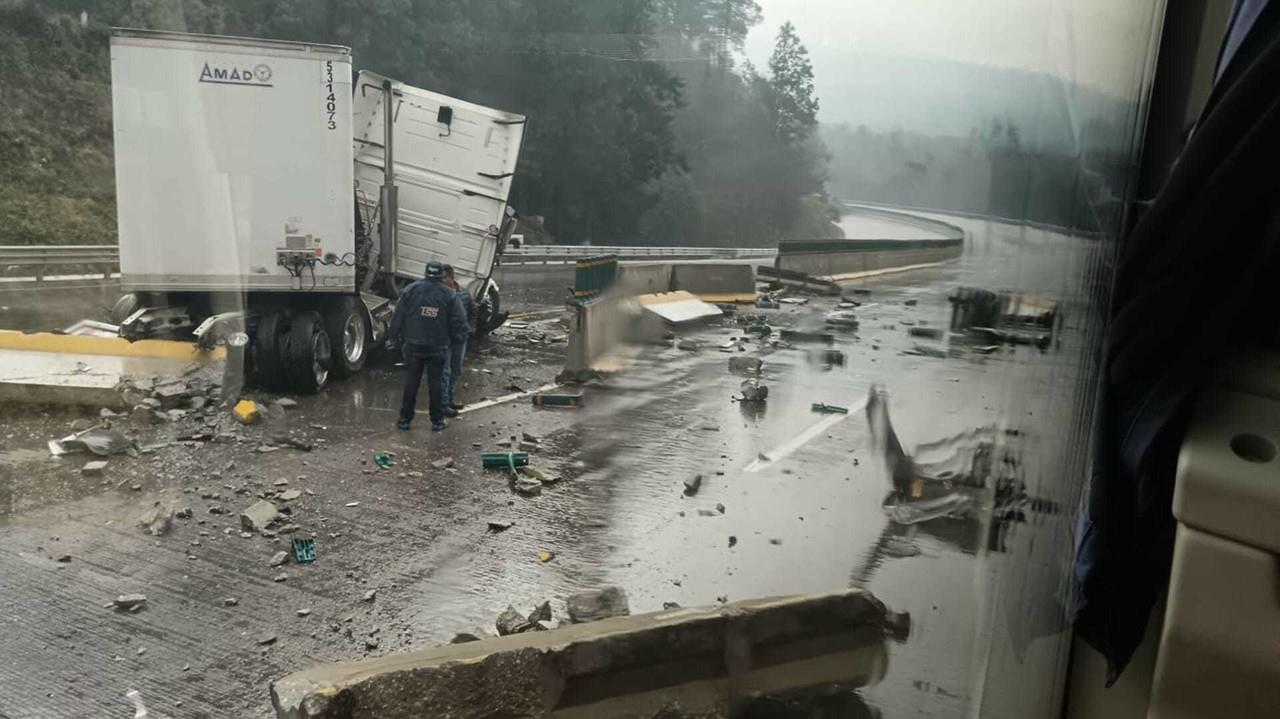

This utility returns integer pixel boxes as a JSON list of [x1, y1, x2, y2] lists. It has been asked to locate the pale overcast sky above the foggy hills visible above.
[[745, 0, 1158, 125]]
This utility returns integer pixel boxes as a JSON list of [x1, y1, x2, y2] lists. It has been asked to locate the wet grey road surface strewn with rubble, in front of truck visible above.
[[0, 209, 1092, 719]]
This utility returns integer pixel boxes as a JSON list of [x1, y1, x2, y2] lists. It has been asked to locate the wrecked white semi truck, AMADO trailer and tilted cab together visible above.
[[111, 29, 525, 391]]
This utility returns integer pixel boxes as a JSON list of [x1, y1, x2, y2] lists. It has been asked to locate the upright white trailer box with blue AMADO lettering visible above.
[[111, 31, 355, 292]]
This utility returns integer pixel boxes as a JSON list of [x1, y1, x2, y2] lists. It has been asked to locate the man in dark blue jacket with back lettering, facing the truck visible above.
[[389, 261, 468, 432]]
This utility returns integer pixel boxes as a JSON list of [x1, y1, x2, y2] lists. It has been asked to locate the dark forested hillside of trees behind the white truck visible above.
[[0, 0, 840, 246]]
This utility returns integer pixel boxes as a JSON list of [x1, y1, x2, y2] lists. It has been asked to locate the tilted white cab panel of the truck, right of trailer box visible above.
[[352, 72, 525, 284]]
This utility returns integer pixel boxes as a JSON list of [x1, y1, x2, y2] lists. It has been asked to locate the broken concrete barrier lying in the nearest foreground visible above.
[[271, 590, 904, 719]]
